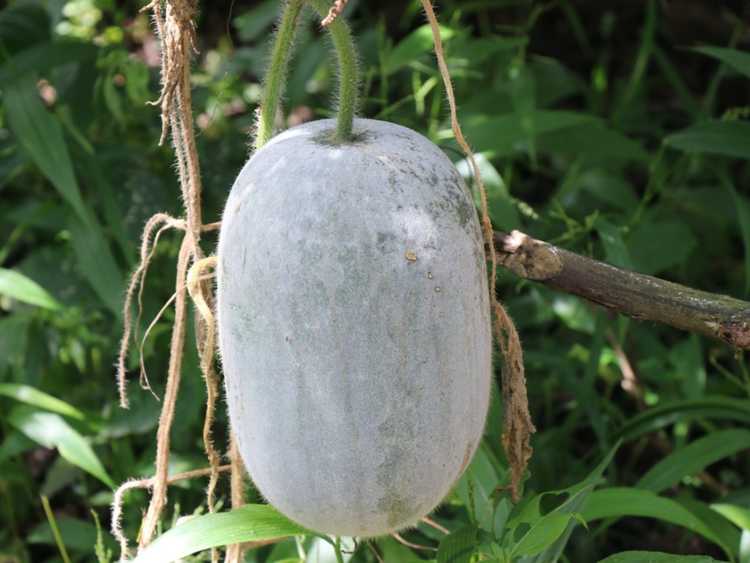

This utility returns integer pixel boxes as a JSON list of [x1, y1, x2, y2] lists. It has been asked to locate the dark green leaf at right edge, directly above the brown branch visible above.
[[664, 121, 750, 158]]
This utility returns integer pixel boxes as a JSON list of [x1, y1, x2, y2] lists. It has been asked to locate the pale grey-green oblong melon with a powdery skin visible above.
[[218, 119, 492, 537]]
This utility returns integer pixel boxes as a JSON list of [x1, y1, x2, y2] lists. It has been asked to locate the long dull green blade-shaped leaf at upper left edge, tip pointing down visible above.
[[3, 78, 90, 223]]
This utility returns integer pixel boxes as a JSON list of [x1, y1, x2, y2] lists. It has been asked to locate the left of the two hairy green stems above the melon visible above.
[[255, 0, 304, 150]]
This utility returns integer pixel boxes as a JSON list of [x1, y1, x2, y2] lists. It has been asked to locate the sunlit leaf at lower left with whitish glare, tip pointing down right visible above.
[[7, 406, 115, 488]]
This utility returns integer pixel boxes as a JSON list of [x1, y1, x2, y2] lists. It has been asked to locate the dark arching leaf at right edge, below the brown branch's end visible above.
[[619, 397, 750, 440]]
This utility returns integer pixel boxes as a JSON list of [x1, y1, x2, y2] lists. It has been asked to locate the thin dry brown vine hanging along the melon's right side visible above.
[[420, 0, 536, 501]]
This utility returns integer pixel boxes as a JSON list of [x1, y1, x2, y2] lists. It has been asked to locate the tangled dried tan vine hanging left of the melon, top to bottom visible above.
[[113, 0, 236, 561]]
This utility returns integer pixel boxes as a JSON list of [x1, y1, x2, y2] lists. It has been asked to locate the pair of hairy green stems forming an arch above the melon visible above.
[[255, 0, 359, 150]]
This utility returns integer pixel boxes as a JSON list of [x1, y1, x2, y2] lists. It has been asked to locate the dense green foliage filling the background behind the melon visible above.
[[0, 0, 750, 563]]
